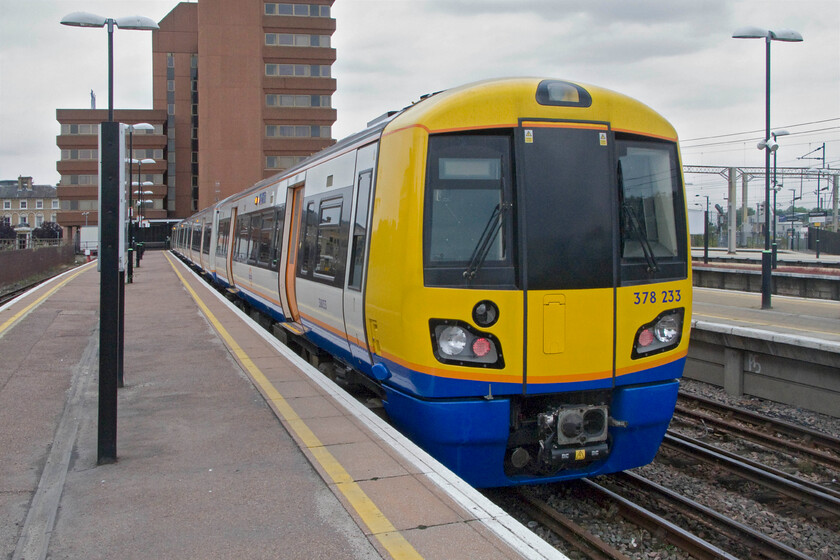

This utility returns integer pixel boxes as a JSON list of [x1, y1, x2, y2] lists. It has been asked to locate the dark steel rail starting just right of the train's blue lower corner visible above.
[[662, 434, 840, 517]]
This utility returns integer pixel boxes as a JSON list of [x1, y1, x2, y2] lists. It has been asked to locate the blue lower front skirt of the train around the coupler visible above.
[[384, 379, 679, 488]]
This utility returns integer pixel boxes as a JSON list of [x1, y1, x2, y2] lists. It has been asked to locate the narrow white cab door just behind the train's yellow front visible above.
[[344, 144, 376, 369]]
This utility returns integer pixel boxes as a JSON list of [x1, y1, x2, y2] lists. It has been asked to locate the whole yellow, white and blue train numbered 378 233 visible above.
[[172, 78, 692, 487]]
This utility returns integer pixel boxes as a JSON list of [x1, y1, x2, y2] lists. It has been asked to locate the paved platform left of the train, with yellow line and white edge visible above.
[[0, 251, 564, 560]]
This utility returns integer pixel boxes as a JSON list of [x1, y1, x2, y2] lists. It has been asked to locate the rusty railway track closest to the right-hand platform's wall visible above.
[[676, 393, 840, 472]]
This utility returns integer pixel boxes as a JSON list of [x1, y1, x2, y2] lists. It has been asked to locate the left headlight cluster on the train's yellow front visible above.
[[429, 319, 504, 368]]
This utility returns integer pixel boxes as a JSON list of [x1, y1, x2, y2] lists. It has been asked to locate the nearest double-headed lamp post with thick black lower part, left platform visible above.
[[61, 12, 158, 465]]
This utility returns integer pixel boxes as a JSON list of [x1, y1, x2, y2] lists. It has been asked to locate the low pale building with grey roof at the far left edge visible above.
[[0, 177, 59, 228]]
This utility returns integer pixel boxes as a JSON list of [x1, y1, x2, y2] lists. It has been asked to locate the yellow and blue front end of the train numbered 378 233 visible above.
[[364, 79, 691, 487]]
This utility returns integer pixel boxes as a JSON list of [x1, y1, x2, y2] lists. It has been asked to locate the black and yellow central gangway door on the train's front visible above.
[[516, 121, 616, 394]]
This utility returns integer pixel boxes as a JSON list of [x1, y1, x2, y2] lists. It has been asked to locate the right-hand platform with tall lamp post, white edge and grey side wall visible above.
[[685, 287, 840, 417]]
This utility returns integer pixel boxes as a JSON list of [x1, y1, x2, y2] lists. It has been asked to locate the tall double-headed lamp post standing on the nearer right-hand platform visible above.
[[732, 27, 802, 309]]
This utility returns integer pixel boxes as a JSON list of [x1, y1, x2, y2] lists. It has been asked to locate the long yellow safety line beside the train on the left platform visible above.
[[166, 255, 423, 560]]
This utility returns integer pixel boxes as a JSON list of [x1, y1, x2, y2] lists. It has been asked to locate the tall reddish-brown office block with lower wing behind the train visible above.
[[56, 0, 336, 239]]
